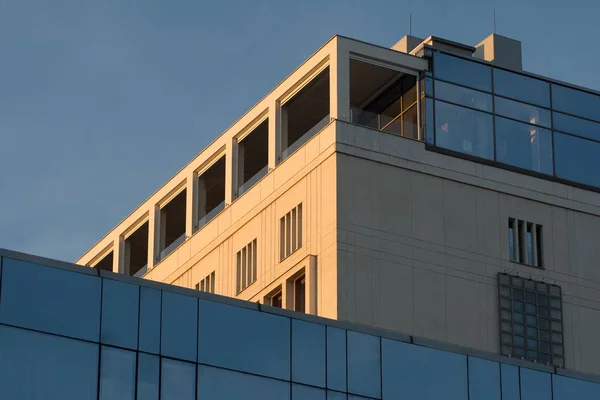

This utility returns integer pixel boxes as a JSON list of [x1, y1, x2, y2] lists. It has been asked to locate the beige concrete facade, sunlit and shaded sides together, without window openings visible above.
[[77, 36, 600, 374]]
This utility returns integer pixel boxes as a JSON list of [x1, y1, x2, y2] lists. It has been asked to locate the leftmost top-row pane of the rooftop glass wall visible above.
[[433, 52, 492, 92]]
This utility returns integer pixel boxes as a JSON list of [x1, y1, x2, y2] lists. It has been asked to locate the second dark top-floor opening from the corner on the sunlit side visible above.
[[237, 120, 269, 196]]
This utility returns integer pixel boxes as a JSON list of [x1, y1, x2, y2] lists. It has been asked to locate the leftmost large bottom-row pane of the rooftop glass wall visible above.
[[435, 101, 494, 160]]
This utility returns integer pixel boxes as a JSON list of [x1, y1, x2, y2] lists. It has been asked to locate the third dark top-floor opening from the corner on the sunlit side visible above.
[[197, 157, 225, 229]]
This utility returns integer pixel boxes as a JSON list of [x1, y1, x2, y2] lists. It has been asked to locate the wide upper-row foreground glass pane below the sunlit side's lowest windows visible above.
[[198, 300, 290, 380]]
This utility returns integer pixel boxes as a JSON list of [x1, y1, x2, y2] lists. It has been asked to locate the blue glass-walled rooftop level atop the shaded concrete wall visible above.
[[423, 49, 600, 188]]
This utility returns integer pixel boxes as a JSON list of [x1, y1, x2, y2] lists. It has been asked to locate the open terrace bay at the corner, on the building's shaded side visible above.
[[350, 59, 419, 139]]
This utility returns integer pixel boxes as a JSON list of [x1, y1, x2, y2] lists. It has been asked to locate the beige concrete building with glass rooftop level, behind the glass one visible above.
[[77, 35, 600, 378]]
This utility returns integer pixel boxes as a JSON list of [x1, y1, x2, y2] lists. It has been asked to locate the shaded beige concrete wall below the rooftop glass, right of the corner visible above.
[[336, 123, 600, 374]]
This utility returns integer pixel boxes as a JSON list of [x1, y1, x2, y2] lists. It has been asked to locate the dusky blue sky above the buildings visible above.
[[0, 0, 600, 261]]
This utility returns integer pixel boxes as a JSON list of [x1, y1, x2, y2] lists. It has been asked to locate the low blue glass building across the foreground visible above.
[[0, 250, 600, 400]]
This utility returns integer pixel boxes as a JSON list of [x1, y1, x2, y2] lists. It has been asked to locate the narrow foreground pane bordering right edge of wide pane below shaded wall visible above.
[[469, 357, 501, 400]]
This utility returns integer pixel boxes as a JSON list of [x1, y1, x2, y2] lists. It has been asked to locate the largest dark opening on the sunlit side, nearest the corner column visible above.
[[281, 67, 329, 160]]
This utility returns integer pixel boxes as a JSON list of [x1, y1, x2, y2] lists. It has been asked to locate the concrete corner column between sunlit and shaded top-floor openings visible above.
[[329, 37, 350, 121]]
